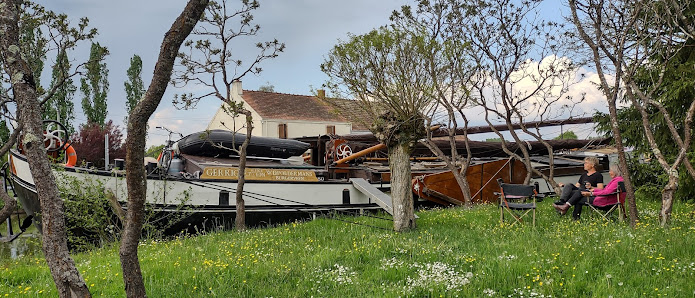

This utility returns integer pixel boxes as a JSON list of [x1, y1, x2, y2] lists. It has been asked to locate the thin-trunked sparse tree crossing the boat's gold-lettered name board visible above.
[[173, 0, 285, 230]]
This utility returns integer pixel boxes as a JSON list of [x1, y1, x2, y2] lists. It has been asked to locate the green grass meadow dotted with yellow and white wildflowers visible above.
[[0, 201, 695, 297]]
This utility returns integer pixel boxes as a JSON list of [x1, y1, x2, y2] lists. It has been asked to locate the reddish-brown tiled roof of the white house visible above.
[[241, 90, 366, 130]]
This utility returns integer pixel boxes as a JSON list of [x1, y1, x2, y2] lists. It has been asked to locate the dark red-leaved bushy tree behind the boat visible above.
[[71, 120, 126, 168]]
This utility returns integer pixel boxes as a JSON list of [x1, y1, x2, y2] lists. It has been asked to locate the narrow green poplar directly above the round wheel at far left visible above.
[[43, 51, 77, 134]]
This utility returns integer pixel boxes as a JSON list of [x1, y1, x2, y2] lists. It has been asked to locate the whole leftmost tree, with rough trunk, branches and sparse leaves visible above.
[[0, 0, 96, 297]]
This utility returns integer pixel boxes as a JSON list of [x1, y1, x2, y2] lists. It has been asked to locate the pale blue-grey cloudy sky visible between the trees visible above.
[[37, 0, 603, 146]]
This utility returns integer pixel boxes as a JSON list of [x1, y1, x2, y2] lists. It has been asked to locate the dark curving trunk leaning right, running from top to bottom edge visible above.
[[119, 0, 208, 297]]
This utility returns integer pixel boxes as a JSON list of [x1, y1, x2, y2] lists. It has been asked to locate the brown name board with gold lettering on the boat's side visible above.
[[200, 167, 319, 181]]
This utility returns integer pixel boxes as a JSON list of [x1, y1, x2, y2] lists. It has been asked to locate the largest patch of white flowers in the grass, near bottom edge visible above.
[[406, 262, 473, 291]]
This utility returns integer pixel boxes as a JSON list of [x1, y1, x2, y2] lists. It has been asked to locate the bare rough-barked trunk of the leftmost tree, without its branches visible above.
[[0, 0, 91, 297]]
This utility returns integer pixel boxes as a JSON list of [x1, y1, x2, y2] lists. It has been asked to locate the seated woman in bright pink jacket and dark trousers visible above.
[[561, 165, 625, 220]]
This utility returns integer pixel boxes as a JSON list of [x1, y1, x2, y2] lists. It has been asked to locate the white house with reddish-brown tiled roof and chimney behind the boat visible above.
[[207, 81, 367, 138]]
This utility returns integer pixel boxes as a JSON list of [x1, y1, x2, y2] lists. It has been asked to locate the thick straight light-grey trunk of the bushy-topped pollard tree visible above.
[[389, 144, 415, 232]]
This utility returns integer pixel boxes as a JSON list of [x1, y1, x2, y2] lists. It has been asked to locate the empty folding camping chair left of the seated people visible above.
[[497, 178, 537, 227]]
